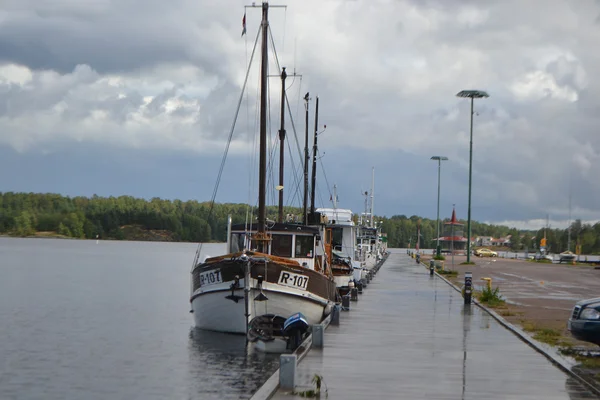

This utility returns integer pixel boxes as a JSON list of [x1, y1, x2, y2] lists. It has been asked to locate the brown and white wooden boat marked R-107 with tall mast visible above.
[[190, 2, 336, 334]]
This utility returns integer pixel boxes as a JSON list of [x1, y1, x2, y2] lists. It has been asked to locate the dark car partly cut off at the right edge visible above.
[[567, 297, 600, 346]]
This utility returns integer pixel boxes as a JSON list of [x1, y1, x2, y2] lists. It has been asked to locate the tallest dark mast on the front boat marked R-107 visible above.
[[256, 2, 269, 252]]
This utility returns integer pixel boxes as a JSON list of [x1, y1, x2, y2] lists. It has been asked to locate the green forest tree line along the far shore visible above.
[[0, 192, 600, 254]]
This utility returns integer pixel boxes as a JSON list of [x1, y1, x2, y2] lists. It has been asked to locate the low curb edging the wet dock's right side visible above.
[[421, 263, 600, 395]]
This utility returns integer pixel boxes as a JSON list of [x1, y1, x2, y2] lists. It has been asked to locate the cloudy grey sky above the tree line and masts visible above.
[[0, 0, 600, 227]]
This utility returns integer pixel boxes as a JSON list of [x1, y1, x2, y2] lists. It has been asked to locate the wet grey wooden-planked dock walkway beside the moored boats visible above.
[[273, 250, 599, 400]]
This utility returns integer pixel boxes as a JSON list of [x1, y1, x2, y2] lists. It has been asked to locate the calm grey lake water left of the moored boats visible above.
[[0, 238, 279, 400]]
